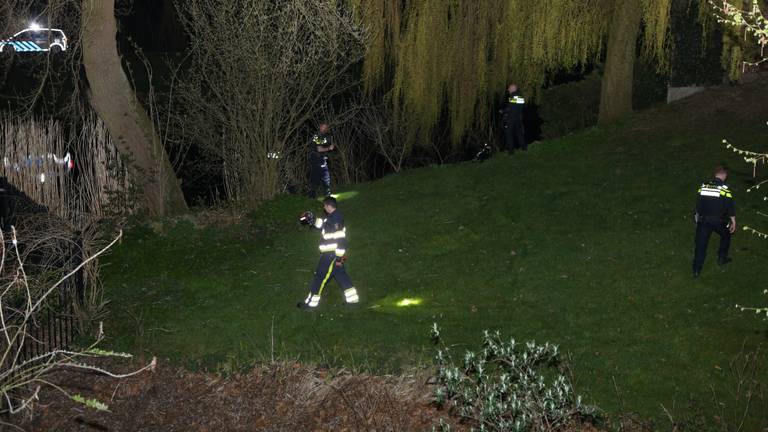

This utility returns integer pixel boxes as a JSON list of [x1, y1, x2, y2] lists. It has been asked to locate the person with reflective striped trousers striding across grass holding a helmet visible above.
[[296, 196, 360, 310]]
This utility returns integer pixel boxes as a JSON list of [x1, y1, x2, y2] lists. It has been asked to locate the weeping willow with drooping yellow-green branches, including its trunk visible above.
[[351, 0, 672, 151]]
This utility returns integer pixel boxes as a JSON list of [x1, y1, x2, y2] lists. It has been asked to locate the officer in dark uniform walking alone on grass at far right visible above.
[[693, 166, 736, 277]]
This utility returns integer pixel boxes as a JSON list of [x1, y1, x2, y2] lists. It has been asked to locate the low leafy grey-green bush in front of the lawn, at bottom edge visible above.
[[432, 324, 596, 432]]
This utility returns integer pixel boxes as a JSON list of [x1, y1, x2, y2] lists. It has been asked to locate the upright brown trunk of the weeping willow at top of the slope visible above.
[[597, 0, 643, 126]]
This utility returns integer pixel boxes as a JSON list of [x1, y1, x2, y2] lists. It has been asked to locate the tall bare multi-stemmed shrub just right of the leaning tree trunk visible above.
[[174, 0, 363, 206]]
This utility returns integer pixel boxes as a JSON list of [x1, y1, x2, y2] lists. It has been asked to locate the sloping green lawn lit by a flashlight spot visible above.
[[104, 78, 768, 422]]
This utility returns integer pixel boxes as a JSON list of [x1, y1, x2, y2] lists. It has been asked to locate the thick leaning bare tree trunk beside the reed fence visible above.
[[83, 0, 187, 216]]
